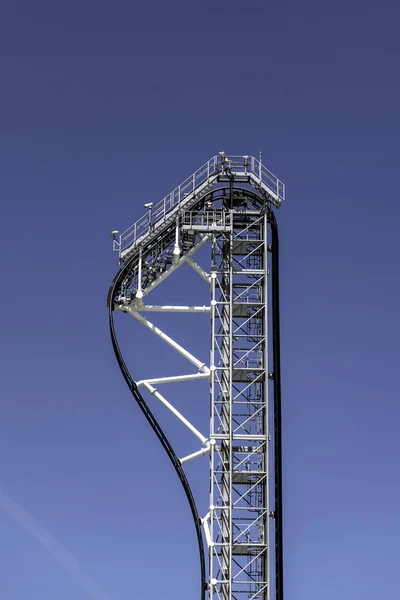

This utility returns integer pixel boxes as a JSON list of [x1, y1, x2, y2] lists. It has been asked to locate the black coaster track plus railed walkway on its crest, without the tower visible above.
[[107, 156, 284, 600]]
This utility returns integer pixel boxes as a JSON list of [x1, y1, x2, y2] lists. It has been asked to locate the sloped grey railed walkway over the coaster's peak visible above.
[[113, 152, 285, 257]]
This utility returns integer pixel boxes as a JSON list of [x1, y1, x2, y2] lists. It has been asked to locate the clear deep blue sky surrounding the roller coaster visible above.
[[0, 0, 400, 600]]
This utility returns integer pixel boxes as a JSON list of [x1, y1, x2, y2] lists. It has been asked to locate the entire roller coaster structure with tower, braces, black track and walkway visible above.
[[107, 153, 285, 600]]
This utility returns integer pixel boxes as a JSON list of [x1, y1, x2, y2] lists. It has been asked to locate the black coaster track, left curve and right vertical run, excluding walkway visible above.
[[107, 189, 283, 600]]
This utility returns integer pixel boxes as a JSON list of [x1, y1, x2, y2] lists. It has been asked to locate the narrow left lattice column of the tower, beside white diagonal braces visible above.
[[209, 225, 233, 600]]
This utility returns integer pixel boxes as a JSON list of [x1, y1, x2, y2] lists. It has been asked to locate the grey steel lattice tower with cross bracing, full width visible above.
[[209, 211, 270, 600]]
